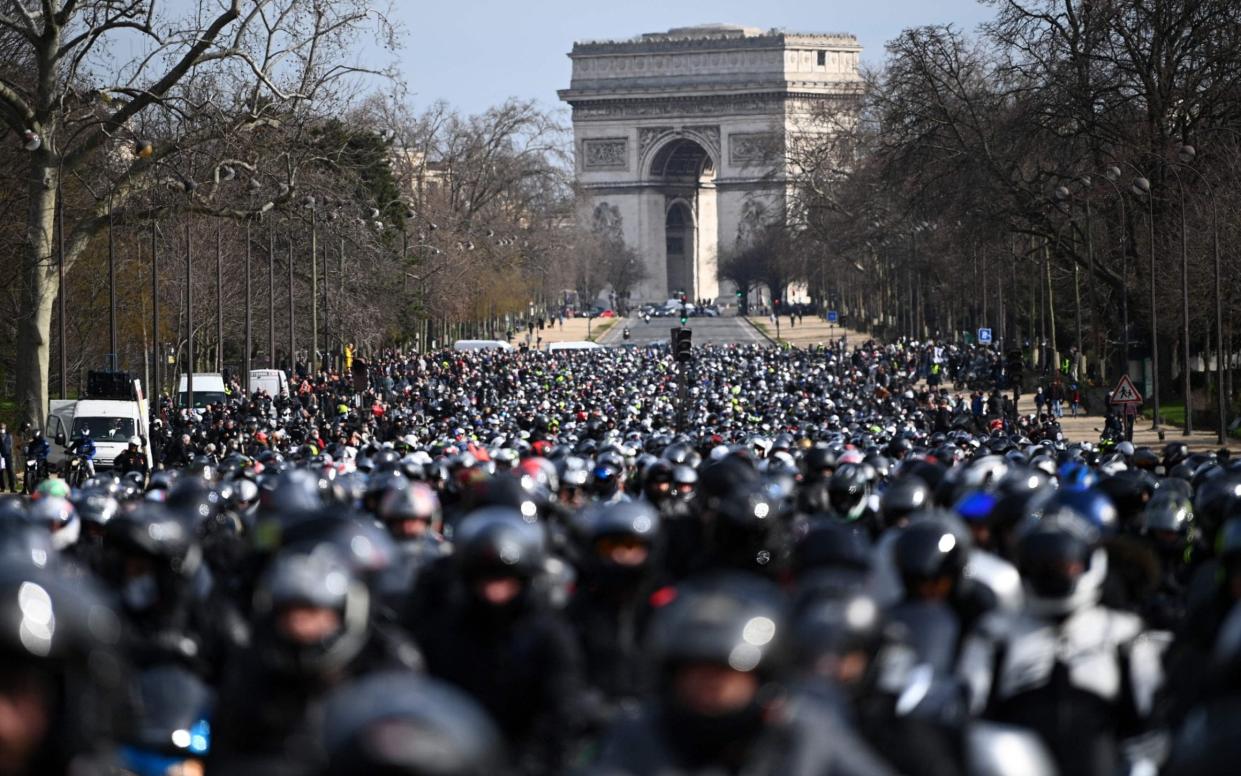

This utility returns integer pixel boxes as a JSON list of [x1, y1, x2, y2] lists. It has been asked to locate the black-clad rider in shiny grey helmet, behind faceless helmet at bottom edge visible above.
[[405, 507, 591, 774]]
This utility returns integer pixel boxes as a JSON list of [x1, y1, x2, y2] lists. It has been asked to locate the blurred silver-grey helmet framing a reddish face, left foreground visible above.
[[253, 546, 370, 674]]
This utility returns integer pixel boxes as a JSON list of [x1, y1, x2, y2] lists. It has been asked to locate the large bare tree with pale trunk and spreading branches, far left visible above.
[[0, 0, 396, 423]]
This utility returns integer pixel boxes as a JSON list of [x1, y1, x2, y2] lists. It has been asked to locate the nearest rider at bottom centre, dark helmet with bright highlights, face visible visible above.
[[592, 575, 887, 776]]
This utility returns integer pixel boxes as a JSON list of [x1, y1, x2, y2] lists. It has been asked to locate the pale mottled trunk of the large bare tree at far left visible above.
[[16, 160, 63, 428]]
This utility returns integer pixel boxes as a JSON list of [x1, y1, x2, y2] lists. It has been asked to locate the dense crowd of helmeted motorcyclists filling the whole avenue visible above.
[[0, 343, 1241, 776]]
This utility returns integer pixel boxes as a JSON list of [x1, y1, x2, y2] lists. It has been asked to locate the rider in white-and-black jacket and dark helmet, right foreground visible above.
[[961, 509, 1162, 775]]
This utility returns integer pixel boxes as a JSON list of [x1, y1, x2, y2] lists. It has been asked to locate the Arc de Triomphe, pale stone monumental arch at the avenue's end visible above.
[[560, 25, 861, 300]]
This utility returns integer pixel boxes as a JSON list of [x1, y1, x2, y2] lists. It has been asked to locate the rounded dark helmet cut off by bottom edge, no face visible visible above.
[[323, 670, 504, 776]]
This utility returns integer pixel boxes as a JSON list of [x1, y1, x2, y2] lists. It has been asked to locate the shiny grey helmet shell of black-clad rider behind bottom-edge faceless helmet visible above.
[[453, 507, 547, 580]]
